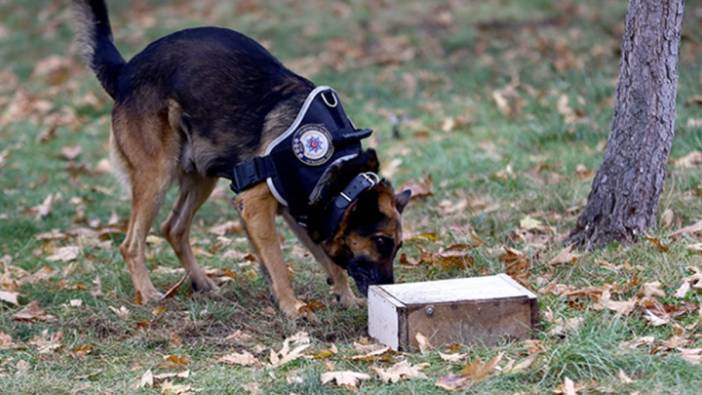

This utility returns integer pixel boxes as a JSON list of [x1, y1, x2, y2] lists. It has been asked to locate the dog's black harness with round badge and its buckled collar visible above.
[[231, 86, 380, 240]]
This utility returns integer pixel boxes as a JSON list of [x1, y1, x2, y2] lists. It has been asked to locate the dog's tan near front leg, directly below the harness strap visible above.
[[234, 183, 315, 320]]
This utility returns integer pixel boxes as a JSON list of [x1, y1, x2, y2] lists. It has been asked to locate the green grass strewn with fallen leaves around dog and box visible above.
[[0, 0, 702, 394]]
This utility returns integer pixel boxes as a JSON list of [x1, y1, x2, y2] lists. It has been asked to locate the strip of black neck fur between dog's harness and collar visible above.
[[309, 148, 380, 207]]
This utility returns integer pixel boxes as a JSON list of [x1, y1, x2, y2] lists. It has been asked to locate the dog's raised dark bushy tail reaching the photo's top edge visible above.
[[72, 0, 125, 99]]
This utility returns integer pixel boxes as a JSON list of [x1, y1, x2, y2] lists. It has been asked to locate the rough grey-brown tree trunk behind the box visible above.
[[569, 0, 684, 249]]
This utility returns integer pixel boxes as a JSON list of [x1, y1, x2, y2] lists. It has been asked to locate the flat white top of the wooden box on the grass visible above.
[[378, 274, 536, 306]]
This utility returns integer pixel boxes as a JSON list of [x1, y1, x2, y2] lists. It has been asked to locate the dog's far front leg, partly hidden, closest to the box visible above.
[[283, 211, 364, 307]]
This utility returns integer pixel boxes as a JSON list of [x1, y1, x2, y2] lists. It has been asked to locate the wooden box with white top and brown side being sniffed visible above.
[[368, 274, 538, 350]]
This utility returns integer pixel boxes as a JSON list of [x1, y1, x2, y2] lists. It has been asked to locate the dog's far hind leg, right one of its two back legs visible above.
[[161, 173, 217, 292]]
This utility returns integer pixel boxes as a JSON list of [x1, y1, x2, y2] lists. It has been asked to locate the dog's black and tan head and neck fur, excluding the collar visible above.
[[313, 149, 411, 296]]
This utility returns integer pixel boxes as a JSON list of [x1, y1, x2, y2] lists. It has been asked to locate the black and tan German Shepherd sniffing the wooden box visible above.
[[73, 0, 411, 319]]
